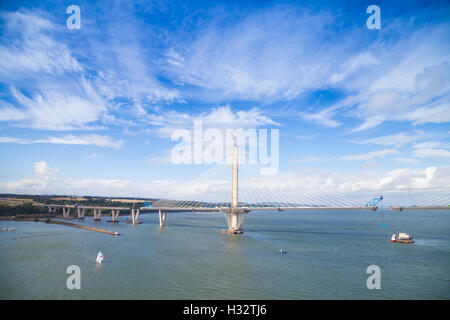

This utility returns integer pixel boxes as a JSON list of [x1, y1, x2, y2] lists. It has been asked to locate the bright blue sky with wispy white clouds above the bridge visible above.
[[0, 1, 450, 204]]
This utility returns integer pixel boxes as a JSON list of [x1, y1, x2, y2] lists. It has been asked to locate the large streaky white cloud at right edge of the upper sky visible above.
[[331, 24, 450, 132]]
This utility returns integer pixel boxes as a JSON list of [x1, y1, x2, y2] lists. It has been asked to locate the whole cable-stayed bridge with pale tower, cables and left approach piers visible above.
[[36, 138, 450, 234]]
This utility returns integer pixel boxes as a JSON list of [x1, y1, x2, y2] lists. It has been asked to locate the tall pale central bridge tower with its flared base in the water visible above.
[[222, 135, 249, 234]]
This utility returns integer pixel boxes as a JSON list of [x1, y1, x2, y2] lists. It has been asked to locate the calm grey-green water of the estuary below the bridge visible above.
[[0, 211, 450, 299]]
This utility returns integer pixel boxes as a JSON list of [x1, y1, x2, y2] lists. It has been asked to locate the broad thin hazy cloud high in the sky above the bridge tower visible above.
[[166, 6, 341, 101]]
